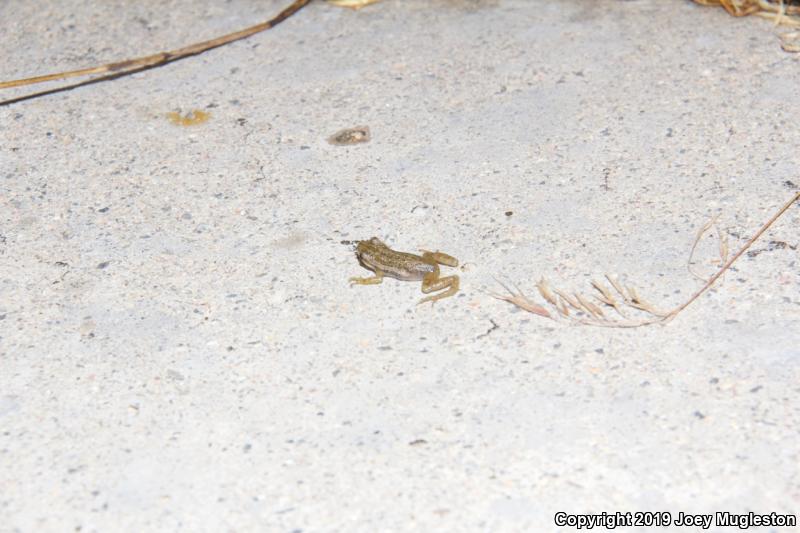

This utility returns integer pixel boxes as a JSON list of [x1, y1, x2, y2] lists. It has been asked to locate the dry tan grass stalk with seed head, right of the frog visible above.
[[490, 192, 800, 328]]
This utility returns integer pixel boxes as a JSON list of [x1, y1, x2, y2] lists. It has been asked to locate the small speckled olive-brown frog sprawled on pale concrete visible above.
[[350, 237, 458, 303]]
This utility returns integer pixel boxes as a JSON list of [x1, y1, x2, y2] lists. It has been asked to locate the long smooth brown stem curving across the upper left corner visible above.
[[0, 0, 311, 106]]
